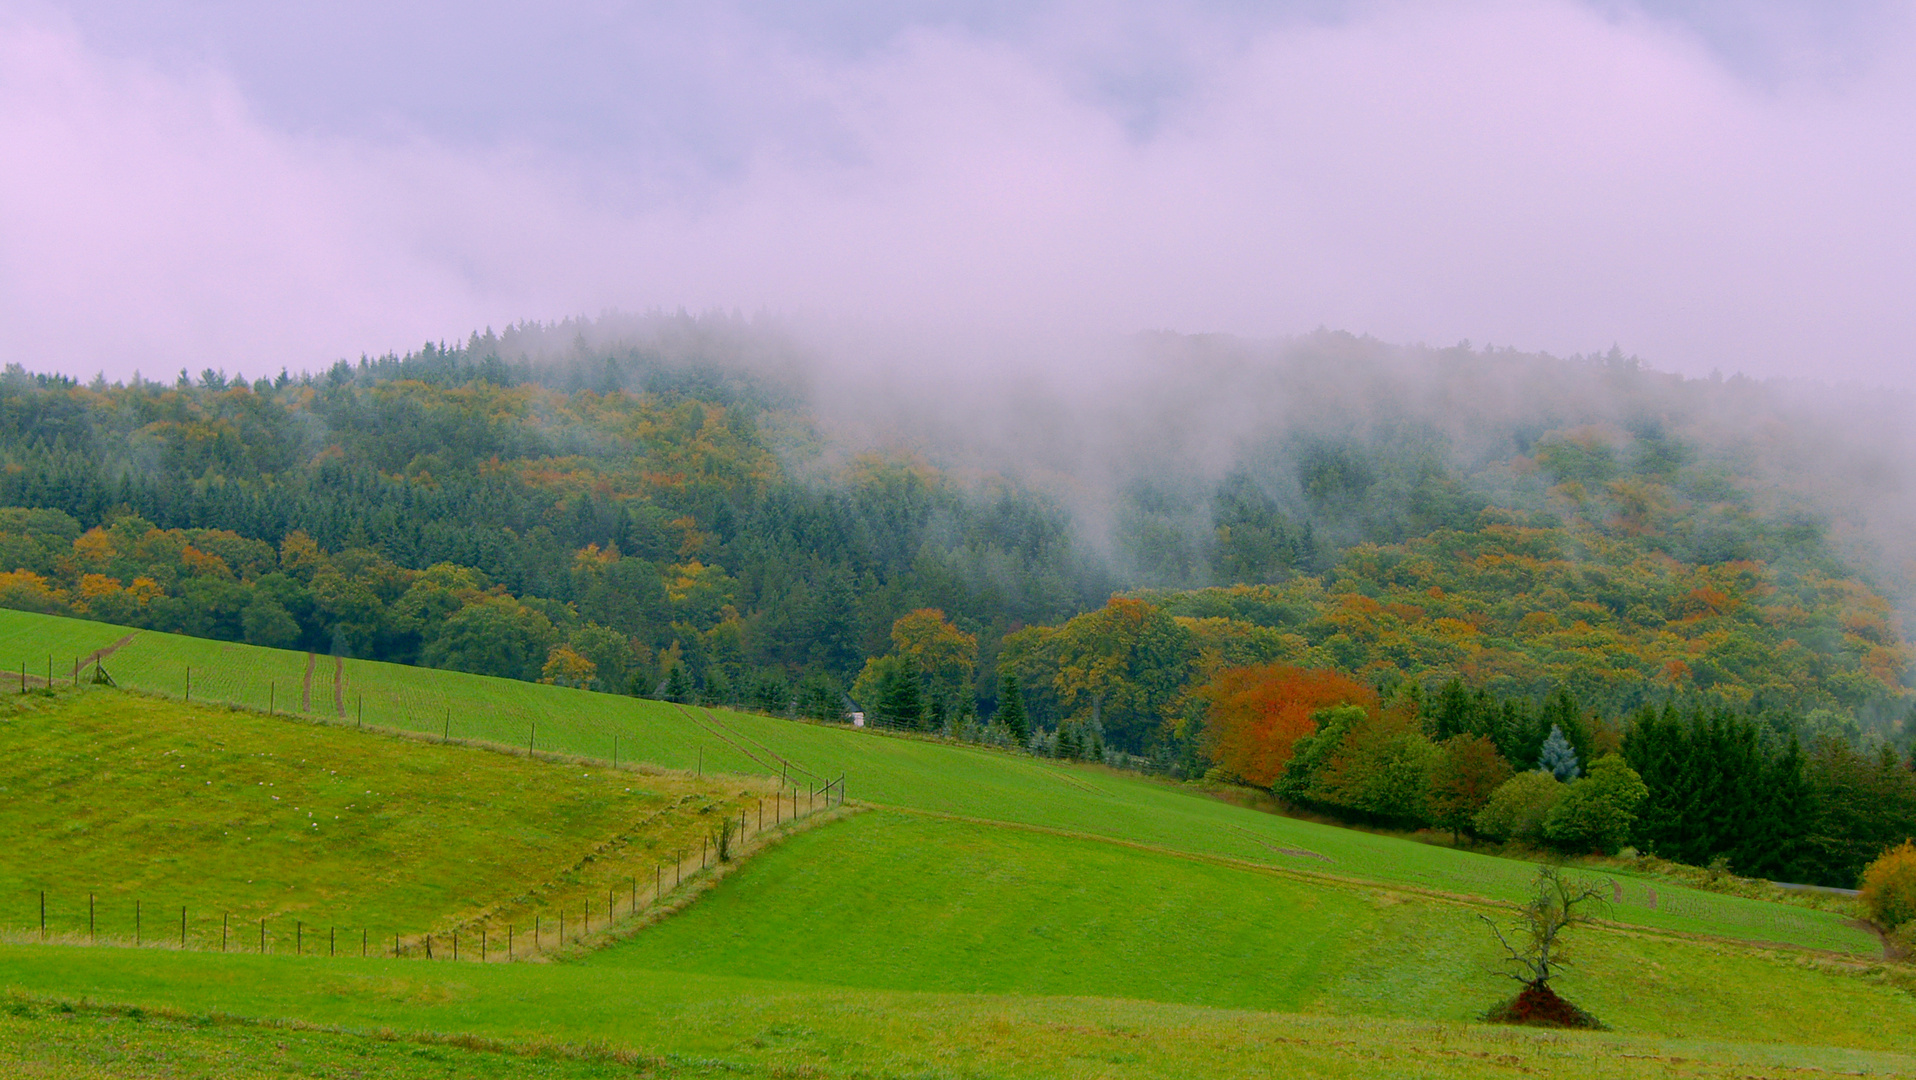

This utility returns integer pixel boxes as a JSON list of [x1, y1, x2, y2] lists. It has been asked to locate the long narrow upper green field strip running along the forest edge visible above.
[[0, 611, 1882, 956]]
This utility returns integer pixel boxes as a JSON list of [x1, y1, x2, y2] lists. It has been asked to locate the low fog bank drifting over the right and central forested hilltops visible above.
[[469, 316, 1916, 612]]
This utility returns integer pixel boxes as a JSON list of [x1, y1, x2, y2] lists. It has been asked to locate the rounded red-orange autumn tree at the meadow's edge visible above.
[[1198, 664, 1378, 787]]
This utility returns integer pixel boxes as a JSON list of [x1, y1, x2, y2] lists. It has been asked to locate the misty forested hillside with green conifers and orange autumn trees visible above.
[[0, 316, 1912, 800]]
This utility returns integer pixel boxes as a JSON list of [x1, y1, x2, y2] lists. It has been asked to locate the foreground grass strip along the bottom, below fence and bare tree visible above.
[[0, 944, 1916, 1080]]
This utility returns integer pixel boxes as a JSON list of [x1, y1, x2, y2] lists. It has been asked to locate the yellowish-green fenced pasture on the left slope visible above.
[[0, 687, 772, 952]]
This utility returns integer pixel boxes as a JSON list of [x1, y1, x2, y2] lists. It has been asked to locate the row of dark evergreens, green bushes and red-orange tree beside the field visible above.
[[1201, 664, 1916, 889]]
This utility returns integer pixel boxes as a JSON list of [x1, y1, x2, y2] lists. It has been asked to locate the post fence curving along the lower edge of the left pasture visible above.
[[29, 776, 845, 963]]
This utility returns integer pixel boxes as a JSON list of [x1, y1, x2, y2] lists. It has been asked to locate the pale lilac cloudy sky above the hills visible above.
[[0, 0, 1916, 389]]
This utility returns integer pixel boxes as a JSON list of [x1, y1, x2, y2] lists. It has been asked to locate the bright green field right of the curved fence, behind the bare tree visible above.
[[586, 812, 1916, 1047]]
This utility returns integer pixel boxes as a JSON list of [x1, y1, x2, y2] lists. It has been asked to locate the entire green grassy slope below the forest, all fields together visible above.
[[0, 613, 1916, 1076]]
